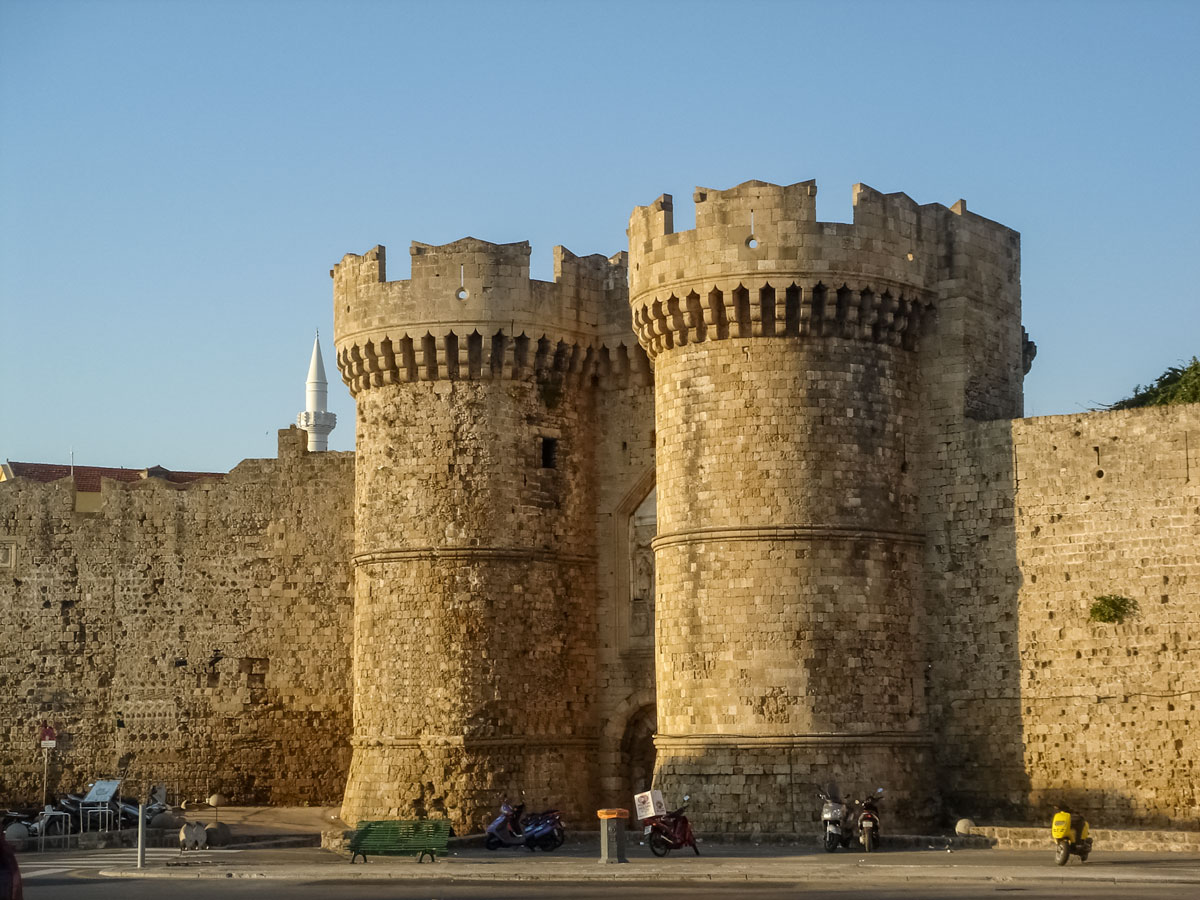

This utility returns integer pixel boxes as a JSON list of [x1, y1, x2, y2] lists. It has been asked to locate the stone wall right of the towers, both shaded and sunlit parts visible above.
[[926, 406, 1200, 827]]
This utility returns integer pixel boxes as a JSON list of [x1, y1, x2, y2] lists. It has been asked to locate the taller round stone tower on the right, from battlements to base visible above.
[[629, 181, 1019, 833]]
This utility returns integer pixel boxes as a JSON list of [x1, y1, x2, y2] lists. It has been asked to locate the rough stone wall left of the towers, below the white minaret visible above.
[[0, 428, 353, 804]]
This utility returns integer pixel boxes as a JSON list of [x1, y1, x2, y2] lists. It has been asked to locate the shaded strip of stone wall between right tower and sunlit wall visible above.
[[922, 415, 1028, 821]]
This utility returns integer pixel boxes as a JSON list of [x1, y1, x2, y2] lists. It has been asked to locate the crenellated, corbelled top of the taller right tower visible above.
[[629, 181, 1020, 358]]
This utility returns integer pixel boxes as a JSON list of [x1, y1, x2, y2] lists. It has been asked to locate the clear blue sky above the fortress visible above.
[[0, 0, 1200, 469]]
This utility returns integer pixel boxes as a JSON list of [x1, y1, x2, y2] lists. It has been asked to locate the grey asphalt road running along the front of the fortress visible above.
[[20, 846, 1200, 900]]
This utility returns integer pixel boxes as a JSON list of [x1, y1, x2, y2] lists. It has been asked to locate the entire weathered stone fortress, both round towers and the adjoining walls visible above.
[[0, 181, 1200, 840]]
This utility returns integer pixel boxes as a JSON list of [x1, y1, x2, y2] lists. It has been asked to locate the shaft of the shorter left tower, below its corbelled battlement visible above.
[[342, 380, 596, 832]]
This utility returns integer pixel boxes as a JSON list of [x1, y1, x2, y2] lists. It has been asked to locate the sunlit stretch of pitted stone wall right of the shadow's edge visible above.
[[1013, 404, 1200, 828]]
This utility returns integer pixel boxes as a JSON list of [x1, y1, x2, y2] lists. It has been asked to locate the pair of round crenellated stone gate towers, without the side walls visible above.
[[332, 181, 1031, 832]]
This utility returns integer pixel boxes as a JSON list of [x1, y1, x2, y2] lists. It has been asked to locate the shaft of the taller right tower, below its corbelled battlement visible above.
[[655, 338, 930, 833]]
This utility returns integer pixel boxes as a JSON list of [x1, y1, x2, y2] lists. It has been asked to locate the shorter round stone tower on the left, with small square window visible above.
[[331, 238, 628, 832]]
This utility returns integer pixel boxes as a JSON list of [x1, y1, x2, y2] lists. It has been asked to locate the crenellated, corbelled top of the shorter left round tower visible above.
[[330, 238, 633, 394]]
